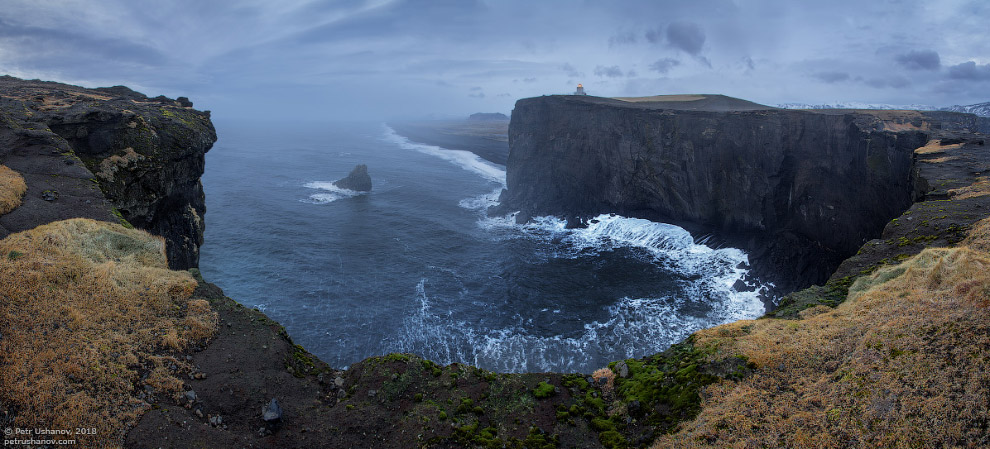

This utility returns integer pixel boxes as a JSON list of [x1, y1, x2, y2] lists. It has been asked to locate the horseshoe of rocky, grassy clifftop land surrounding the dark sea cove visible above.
[[0, 77, 990, 448]]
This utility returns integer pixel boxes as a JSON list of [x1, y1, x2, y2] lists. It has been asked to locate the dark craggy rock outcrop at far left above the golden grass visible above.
[[0, 77, 217, 269]]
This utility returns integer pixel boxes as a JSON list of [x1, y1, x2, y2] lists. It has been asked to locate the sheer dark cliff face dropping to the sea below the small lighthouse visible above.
[[501, 96, 927, 290]]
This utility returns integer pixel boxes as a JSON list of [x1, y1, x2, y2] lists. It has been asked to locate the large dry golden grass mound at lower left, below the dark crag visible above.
[[0, 219, 217, 447]]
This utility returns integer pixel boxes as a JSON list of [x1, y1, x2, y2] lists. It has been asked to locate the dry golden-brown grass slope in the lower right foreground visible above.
[[654, 219, 990, 448]]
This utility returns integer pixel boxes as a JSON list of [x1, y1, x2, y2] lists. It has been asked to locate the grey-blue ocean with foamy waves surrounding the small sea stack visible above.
[[200, 122, 764, 373]]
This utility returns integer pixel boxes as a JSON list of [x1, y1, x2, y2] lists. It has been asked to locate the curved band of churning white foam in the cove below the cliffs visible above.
[[392, 215, 764, 372]]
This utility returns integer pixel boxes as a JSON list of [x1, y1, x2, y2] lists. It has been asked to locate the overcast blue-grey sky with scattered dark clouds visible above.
[[0, 0, 990, 119]]
